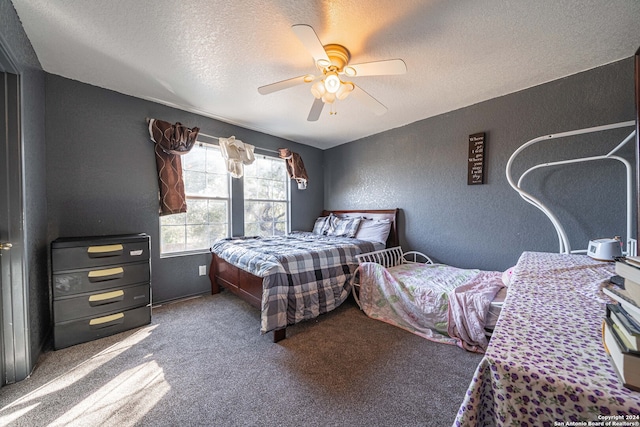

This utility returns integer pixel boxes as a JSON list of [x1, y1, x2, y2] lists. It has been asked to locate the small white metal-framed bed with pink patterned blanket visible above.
[[354, 247, 509, 353]]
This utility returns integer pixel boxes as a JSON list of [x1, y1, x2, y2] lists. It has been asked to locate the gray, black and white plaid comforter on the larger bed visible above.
[[211, 232, 374, 333]]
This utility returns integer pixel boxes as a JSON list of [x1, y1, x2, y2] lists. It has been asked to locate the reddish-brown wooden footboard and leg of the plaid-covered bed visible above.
[[209, 254, 287, 342]]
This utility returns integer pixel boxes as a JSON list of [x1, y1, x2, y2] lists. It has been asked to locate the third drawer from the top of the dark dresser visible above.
[[53, 283, 151, 323]]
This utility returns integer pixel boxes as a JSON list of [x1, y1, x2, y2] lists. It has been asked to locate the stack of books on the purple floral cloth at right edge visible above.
[[602, 257, 640, 391]]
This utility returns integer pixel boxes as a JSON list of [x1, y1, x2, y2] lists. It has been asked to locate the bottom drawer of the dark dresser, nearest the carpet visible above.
[[53, 307, 151, 350]]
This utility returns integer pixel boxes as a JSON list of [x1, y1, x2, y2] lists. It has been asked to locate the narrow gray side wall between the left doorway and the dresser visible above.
[[0, 0, 50, 374]]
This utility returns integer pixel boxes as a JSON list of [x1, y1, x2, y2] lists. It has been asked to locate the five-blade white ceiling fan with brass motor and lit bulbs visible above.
[[258, 24, 407, 122]]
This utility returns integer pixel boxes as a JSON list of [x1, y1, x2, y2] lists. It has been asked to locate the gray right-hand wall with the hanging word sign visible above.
[[324, 57, 635, 270]]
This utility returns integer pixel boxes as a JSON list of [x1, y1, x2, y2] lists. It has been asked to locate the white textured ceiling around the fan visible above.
[[8, 0, 640, 149]]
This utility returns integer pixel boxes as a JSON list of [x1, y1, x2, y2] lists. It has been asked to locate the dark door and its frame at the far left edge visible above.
[[0, 35, 31, 387]]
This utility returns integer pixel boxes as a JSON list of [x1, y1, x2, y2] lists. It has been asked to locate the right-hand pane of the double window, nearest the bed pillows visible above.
[[243, 156, 289, 236]]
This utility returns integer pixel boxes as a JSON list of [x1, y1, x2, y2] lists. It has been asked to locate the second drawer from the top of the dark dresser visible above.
[[52, 260, 151, 298]]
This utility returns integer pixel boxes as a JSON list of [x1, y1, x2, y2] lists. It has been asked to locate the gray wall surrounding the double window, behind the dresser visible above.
[[46, 74, 324, 303]]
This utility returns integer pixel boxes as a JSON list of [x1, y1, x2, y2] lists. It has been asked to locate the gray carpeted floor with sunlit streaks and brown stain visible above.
[[0, 292, 481, 427]]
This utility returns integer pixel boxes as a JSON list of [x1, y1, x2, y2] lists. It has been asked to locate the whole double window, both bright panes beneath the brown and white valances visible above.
[[160, 144, 290, 255]]
